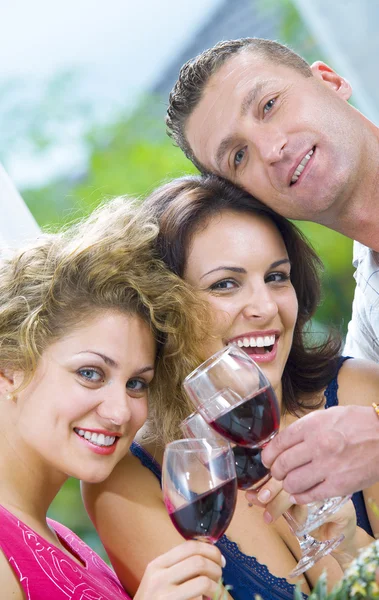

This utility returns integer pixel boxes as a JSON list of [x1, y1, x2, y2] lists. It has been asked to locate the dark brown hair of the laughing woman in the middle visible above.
[[144, 175, 341, 413]]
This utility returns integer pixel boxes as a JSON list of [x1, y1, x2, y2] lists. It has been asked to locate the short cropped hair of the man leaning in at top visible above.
[[166, 38, 312, 173]]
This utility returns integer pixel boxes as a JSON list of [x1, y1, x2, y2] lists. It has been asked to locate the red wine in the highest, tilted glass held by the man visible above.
[[209, 386, 279, 446]]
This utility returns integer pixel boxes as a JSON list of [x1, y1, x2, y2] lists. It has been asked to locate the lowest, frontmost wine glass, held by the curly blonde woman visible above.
[[162, 439, 237, 544]]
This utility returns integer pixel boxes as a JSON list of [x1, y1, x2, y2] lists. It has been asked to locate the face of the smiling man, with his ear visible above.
[[185, 51, 363, 225]]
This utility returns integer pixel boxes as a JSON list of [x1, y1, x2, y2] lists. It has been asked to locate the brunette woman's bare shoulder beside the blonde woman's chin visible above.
[[82, 440, 183, 596]]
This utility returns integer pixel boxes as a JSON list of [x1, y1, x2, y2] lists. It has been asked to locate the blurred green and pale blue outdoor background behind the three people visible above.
[[0, 0, 379, 552]]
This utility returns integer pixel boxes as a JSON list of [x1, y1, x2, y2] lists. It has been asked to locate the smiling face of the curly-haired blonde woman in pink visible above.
[[5, 311, 156, 482]]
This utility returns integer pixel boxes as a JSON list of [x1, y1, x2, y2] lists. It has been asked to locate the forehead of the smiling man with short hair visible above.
[[185, 50, 304, 173]]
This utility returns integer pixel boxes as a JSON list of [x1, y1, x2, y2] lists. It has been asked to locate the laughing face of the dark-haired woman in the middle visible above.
[[184, 210, 298, 395]]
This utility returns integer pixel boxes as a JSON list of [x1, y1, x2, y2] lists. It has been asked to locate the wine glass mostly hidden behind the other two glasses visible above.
[[180, 412, 344, 577]]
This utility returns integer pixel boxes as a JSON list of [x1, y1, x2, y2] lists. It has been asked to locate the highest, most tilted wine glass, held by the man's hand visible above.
[[183, 345, 350, 535]]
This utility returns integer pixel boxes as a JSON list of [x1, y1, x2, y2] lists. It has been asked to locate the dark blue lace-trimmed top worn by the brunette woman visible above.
[[130, 357, 373, 600]]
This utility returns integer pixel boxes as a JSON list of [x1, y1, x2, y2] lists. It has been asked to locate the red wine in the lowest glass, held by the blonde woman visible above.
[[166, 479, 237, 542]]
